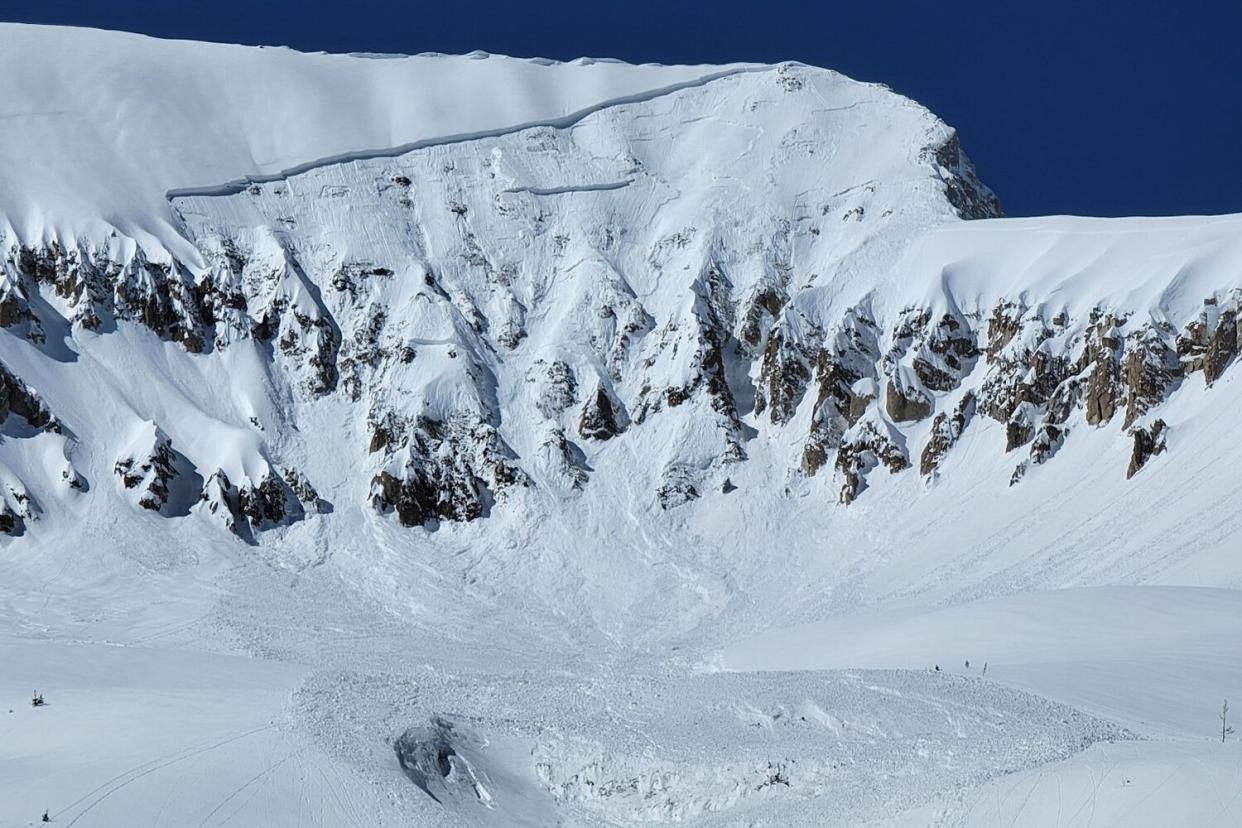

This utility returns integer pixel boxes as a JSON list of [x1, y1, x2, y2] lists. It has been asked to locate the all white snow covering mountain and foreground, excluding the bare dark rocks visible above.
[[0, 25, 1242, 827]]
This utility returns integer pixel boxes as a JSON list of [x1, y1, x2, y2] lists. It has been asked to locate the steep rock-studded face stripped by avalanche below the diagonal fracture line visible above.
[[173, 67, 987, 524]]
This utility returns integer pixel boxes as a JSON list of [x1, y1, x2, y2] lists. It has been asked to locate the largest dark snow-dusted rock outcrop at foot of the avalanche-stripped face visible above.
[[371, 415, 529, 526]]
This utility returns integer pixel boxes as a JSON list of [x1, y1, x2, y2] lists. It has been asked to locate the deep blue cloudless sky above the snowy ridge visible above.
[[0, 0, 1242, 216]]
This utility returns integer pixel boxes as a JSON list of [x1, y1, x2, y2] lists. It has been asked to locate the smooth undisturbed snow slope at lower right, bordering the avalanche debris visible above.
[[722, 586, 1242, 826]]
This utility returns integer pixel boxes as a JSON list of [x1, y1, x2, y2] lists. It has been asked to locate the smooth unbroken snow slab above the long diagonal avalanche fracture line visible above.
[[0, 24, 741, 246]]
